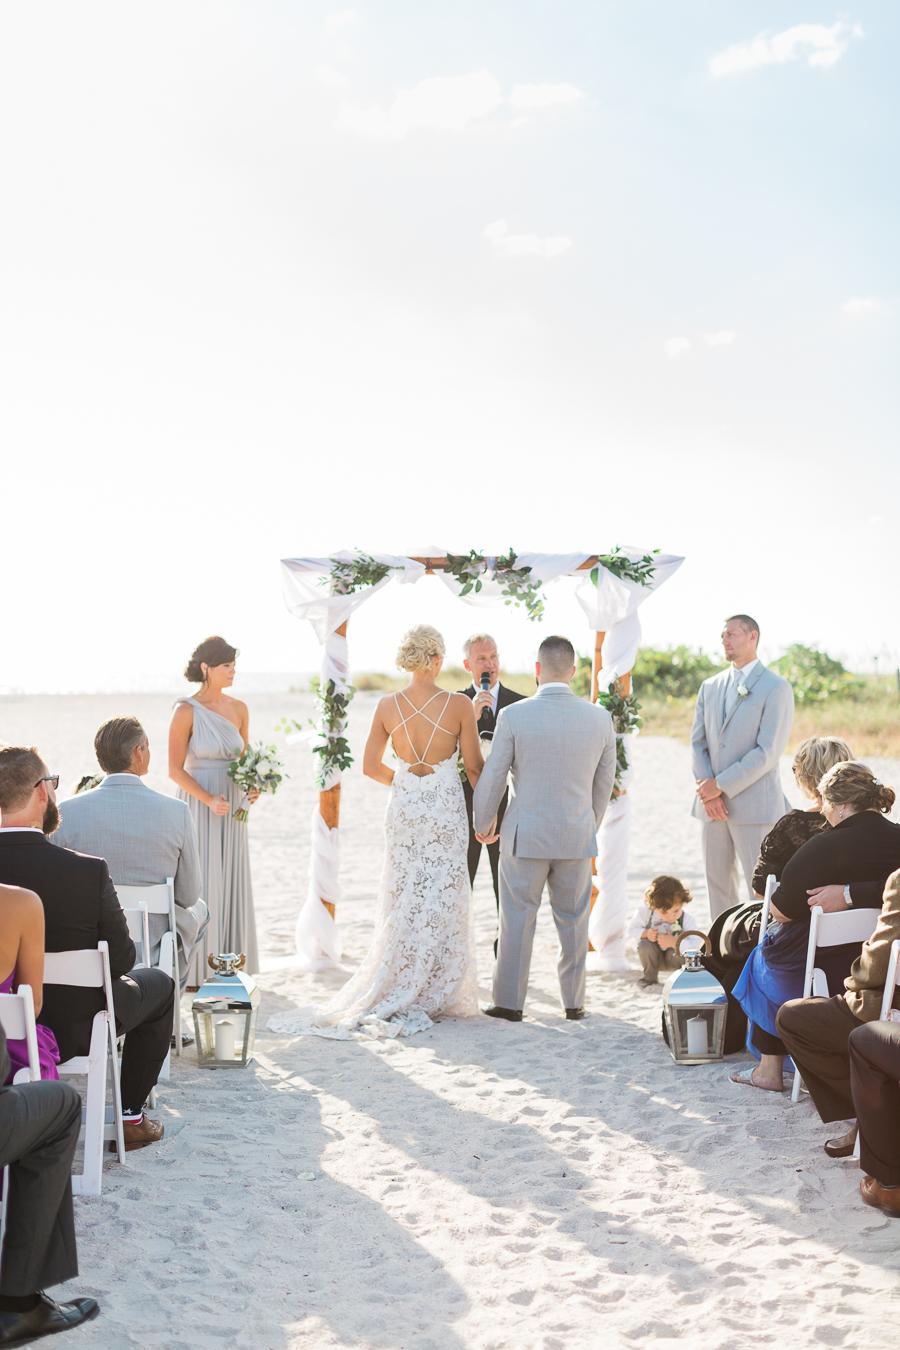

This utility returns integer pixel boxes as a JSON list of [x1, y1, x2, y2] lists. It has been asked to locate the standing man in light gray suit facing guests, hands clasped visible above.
[[691, 614, 793, 919]]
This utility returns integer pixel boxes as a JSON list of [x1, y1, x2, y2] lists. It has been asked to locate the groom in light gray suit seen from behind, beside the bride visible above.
[[472, 637, 615, 1022]]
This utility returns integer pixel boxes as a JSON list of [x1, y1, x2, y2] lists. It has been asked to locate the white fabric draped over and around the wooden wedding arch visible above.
[[282, 547, 684, 971]]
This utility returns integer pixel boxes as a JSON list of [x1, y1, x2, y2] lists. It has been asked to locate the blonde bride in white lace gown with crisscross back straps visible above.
[[312, 624, 484, 1037]]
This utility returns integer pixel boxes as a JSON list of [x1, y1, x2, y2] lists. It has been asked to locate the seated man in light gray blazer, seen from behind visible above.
[[53, 717, 209, 988]]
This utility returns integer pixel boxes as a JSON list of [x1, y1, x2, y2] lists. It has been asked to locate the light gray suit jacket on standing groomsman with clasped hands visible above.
[[691, 662, 793, 825]]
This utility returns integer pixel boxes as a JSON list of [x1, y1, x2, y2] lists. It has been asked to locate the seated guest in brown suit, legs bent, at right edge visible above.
[[775, 872, 900, 1158]]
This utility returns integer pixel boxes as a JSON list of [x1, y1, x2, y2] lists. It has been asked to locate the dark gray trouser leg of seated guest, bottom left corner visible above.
[[0, 1081, 81, 1297]]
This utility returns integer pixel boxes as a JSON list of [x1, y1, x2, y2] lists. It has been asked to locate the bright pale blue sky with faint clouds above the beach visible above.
[[0, 0, 900, 690]]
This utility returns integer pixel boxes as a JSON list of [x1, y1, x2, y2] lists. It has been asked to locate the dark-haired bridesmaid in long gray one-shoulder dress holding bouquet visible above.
[[169, 637, 259, 986]]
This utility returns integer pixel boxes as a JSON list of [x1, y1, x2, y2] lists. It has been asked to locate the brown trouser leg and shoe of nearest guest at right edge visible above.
[[850, 1022, 900, 1219]]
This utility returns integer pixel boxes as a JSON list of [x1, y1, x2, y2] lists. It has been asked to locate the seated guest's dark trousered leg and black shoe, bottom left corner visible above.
[[0, 1027, 100, 1346]]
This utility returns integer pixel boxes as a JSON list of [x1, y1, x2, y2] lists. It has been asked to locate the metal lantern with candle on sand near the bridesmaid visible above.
[[192, 952, 259, 1069]]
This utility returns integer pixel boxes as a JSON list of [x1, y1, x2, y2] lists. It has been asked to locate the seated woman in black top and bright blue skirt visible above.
[[731, 760, 900, 1092]]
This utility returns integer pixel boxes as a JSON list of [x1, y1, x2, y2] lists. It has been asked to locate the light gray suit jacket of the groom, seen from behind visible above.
[[474, 686, 615, 860]]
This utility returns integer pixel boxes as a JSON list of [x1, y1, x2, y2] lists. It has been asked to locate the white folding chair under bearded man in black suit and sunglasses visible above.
[[43, 942, 125, 1195]]
